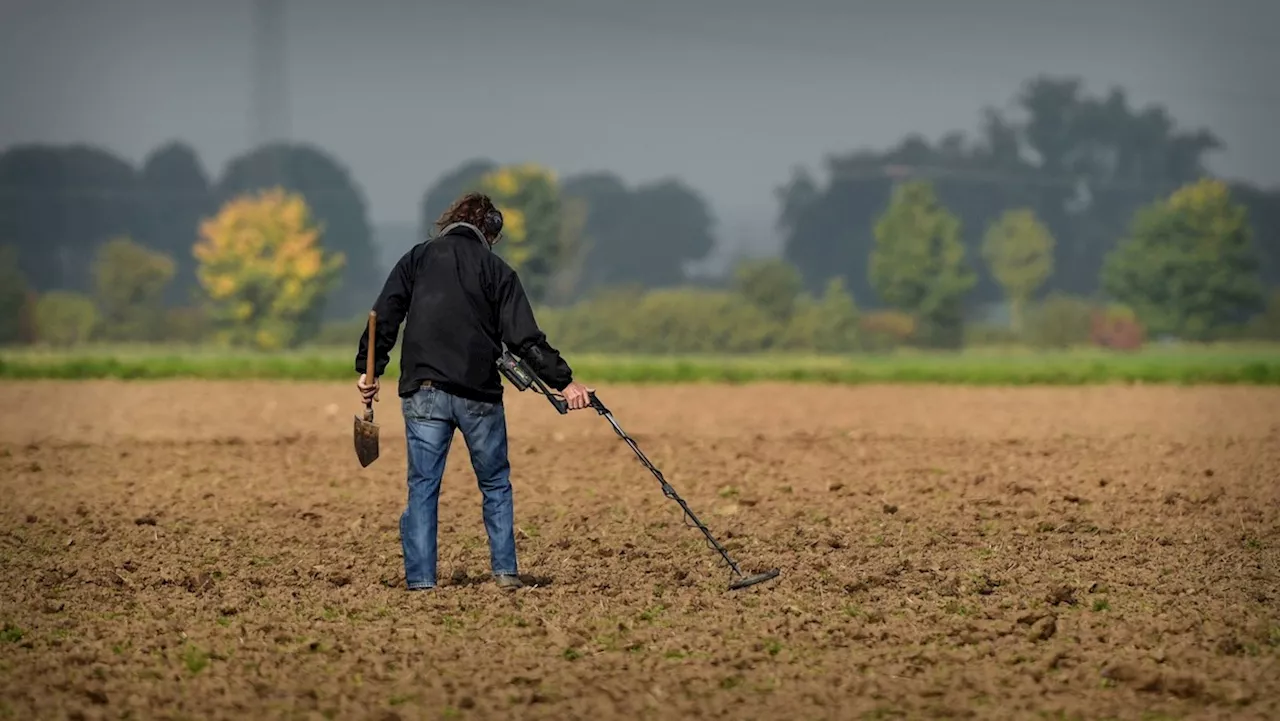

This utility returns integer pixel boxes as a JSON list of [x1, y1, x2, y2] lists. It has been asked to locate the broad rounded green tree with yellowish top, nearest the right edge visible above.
[[1102, 179, 1263, 341]]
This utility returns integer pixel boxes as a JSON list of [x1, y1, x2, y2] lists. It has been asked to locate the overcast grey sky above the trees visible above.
[[0, 0, 1280, 253]]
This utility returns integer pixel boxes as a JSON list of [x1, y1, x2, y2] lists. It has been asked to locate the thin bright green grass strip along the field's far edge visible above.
[[0, 347, 1280, 385]]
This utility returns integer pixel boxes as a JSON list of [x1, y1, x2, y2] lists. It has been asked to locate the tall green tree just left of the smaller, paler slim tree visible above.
[[869, 182, 977, 347]]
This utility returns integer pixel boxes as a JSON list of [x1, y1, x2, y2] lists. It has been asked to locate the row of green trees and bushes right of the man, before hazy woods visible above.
[[544, 178, 1280, 352]]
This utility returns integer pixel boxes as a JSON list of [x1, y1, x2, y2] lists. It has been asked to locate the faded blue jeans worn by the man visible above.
[[399, 387, 516, 589]]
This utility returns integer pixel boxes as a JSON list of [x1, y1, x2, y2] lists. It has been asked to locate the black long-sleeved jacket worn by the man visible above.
[[356, 223, 573, 402]]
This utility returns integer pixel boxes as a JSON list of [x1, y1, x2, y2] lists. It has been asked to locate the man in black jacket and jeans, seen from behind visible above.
[[356, 193, 590, 590]]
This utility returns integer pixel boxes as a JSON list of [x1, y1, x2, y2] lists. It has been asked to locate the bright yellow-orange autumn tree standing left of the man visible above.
[[193, 188, 344, 350]]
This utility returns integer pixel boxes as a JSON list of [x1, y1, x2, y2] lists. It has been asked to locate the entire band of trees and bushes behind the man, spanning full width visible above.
[[0, 77, 1280, 351]]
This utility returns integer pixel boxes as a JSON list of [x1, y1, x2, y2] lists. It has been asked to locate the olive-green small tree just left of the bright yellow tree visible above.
[[93, 237, 175, 341]]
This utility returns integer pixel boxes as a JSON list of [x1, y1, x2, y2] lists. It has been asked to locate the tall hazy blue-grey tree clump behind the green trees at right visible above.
[[778, 77, 1223, 302]]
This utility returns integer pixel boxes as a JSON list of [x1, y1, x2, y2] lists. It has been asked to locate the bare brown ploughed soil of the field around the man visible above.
[[0, 383, 1280, 721]]
